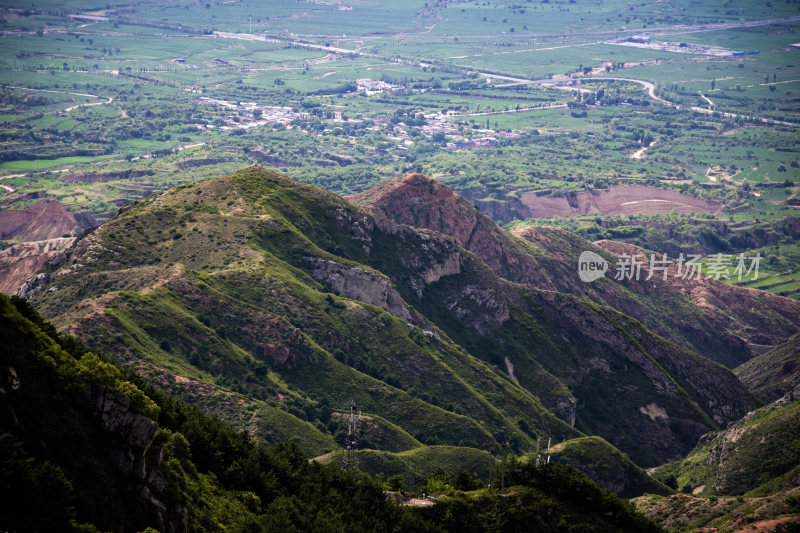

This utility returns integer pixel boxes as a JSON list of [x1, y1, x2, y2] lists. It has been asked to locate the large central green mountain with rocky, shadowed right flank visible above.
[[25, 167, 752, 465]]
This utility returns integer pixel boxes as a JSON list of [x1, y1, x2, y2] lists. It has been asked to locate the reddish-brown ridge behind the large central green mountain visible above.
[[348, 174, 800, 367]]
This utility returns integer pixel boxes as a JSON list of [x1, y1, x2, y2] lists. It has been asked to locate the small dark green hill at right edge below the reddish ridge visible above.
[[733, 335, 800, 402]]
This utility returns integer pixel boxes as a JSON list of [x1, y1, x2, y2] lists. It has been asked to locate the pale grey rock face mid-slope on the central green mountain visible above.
[[307, 257, 411, 320]]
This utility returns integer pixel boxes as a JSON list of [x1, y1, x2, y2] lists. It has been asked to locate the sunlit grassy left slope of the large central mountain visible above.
[[28, 171, 576, 454]]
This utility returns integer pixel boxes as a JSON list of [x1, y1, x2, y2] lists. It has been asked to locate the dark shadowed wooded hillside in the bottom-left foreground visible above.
[[0, 295, 660, 532]]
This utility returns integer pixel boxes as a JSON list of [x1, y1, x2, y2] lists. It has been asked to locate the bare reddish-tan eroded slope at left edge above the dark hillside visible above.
[[0, 237, 75, 293]]
